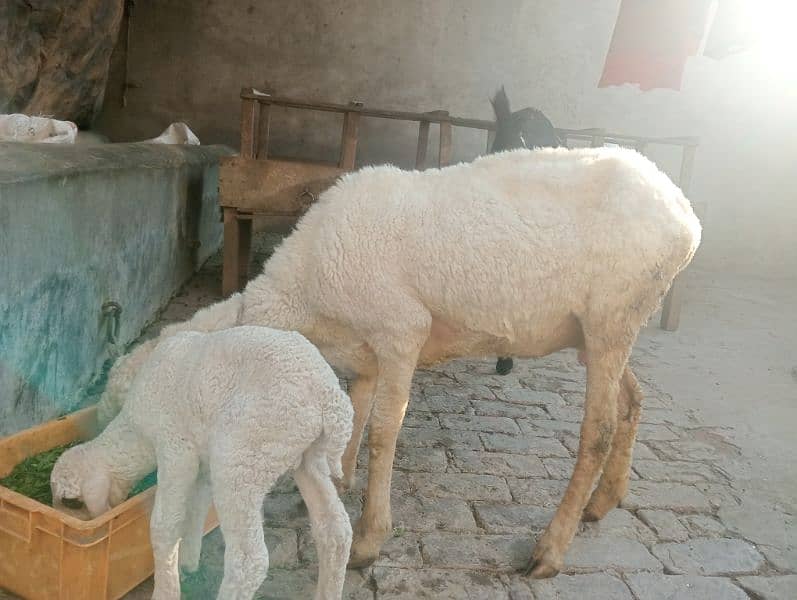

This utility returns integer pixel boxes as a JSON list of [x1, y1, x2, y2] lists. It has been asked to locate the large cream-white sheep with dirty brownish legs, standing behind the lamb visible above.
[[96, 148, 701, 577]]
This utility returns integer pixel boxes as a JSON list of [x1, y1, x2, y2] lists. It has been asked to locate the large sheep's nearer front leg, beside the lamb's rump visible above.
[[349, 362, 415, 568]]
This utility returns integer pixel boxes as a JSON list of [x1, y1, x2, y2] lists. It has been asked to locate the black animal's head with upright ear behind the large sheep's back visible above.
[[490, 86, 563, 152]]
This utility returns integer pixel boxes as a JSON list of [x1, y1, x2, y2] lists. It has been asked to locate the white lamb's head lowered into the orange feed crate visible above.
[[50, 442, 132, 519]]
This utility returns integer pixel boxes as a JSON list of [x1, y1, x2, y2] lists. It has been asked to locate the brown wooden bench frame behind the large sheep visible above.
[[219, 88, 698, 331]]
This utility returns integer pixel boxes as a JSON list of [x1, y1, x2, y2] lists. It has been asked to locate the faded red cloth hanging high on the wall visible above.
[[598, 0, 712, 90]]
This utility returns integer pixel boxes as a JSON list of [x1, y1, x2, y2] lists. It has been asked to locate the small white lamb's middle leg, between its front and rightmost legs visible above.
[[210, 450, 276, 600]]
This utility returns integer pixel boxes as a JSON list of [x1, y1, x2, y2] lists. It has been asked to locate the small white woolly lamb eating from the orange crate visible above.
[[51, 327, 353, 600]]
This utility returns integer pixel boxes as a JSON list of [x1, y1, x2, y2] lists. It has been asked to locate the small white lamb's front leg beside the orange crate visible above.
[[150, 449, 199, 600]]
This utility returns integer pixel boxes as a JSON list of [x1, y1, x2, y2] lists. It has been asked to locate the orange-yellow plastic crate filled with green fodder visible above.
[[0, 407, 218, 600]]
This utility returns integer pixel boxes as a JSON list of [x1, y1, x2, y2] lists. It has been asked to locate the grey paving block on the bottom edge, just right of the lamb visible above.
[[373, 567, 509, 600]]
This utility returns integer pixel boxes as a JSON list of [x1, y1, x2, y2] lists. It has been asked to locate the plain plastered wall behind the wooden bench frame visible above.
[[99, 0, 797, 277]]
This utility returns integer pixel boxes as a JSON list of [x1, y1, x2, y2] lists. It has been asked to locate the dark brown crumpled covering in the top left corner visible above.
[[0, 0, 124, 127]]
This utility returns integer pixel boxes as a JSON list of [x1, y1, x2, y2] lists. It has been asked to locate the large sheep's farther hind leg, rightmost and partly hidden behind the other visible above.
[[582, 365, 642, 521]]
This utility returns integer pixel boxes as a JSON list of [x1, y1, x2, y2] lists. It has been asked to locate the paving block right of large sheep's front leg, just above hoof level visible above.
[[391, 494, 479, 532]]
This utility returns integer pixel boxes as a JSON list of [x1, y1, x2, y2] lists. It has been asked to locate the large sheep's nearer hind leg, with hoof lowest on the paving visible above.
[[527, 340, 629, 578]]
